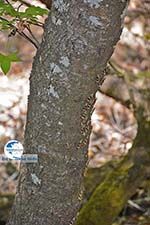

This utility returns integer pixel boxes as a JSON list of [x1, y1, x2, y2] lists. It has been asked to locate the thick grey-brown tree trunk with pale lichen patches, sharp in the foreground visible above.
[[8, 0, 126, 225]]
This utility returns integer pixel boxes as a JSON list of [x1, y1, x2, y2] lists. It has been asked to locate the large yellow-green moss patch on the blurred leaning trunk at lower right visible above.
[[76, 161, 133, 225]]
